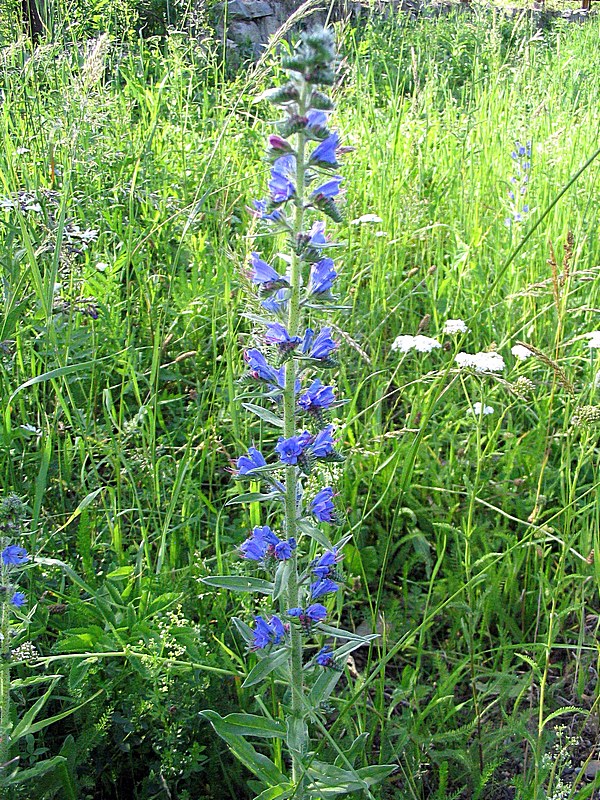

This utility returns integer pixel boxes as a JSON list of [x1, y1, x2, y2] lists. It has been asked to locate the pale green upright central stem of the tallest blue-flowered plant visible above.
[[283, 79, 308, 800]]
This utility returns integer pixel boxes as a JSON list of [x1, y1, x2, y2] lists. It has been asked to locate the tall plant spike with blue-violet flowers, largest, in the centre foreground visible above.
[[202, 30, 394, 800]]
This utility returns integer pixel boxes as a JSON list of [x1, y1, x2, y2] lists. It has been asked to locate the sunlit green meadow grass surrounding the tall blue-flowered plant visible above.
[[0, 4, 600, 800]]
